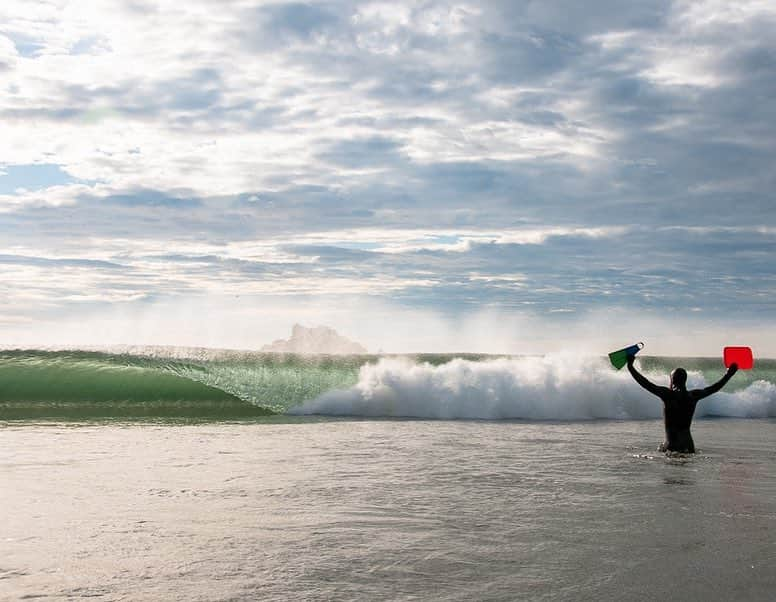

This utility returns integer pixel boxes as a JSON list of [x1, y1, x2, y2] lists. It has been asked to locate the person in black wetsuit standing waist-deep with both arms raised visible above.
[[628, 355, 738, 454]]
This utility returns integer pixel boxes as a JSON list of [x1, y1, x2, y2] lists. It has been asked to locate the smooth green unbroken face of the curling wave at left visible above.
[[0, 350, 368, 420]]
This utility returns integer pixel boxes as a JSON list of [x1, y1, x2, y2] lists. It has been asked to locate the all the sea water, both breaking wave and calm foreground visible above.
[[0, 350, 776, 600]]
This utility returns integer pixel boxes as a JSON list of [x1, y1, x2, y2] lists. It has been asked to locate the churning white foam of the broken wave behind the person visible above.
[[289, 355, 776, 420]]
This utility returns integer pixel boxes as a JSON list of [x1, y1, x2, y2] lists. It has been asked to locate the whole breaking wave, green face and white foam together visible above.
[[0, 349, 776, 420]]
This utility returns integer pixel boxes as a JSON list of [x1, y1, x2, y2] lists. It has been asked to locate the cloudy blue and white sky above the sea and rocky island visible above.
[[0, 0, 776, 357]]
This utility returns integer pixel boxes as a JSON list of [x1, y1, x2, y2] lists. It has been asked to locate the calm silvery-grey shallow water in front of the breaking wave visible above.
[[0, 419, 776, 600]]
